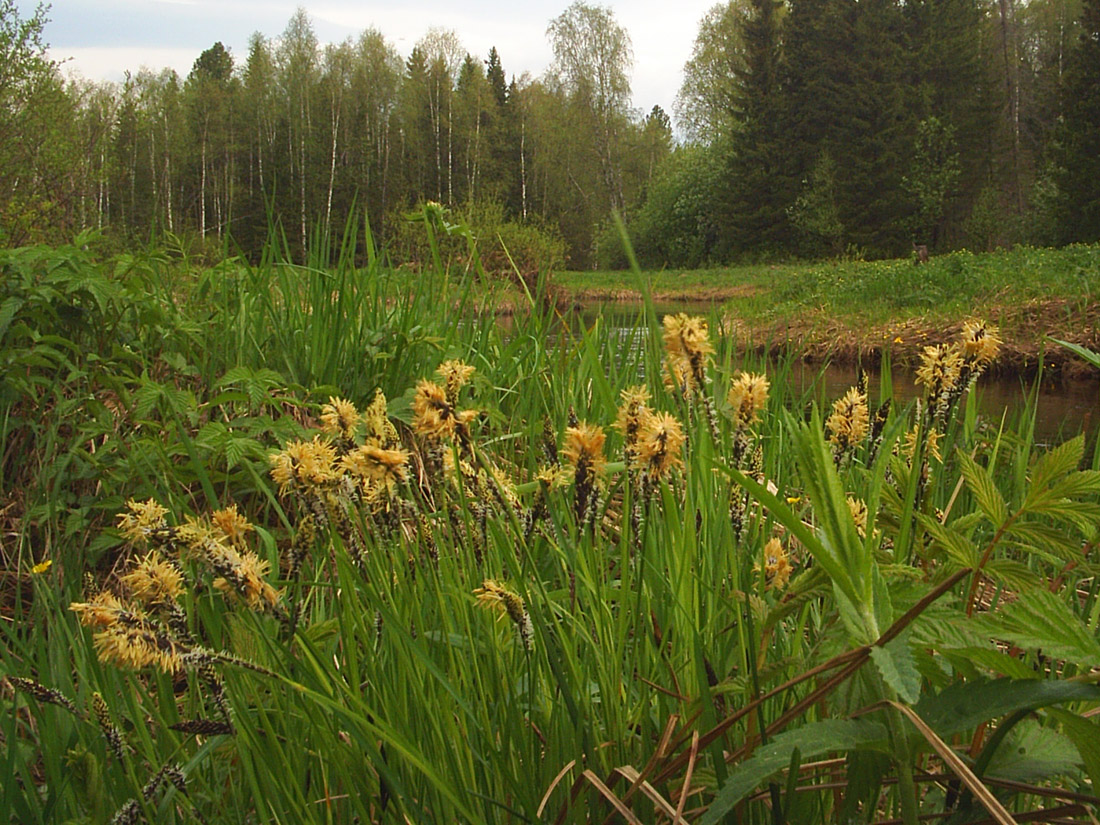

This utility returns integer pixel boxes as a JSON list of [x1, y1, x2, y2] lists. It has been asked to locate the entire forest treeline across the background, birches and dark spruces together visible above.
[[0, 0, 1100, 267]]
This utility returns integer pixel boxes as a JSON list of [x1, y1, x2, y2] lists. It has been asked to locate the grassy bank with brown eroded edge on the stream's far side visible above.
[[556, 246, 1100, 374]]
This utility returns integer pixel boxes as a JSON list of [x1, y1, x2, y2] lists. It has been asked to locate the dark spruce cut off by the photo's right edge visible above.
[[1058, 0, 1100, 242]]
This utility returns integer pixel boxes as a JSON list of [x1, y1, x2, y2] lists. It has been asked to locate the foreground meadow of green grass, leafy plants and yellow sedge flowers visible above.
[[0, 216, 1100, 825]]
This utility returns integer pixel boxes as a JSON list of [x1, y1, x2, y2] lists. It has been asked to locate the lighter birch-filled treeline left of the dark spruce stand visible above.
[[0, 0, 672, 266]]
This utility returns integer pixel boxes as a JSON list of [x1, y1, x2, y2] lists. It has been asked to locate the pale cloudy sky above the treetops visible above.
[[27, 0, 716, 122]]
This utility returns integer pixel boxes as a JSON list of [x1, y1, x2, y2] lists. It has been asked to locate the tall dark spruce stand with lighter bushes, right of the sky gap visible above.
[[631, 0, 1100, 265]]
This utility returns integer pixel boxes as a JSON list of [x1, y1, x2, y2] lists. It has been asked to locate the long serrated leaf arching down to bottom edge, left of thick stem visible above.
[[702, 719, 889, 825]]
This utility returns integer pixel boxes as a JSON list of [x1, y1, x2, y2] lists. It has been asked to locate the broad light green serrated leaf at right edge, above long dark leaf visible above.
[[975, 589, 1100, 667]]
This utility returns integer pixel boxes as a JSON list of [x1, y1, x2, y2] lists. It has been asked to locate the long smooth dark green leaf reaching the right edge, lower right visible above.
[[913, 679, 1100, 737]]
